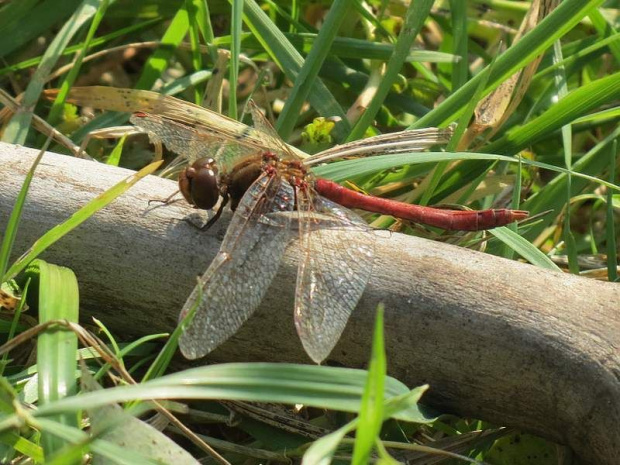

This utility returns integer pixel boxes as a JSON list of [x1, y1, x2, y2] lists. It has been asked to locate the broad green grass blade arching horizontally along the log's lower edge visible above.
[[35, 363, 429, 422]]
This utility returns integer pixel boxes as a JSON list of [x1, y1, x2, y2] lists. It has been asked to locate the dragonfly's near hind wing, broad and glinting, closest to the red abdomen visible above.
[[295, 196, 375, 363]]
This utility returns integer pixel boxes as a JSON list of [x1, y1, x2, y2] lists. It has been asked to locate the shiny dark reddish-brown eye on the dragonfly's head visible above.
[[179, 158, 220, 210]]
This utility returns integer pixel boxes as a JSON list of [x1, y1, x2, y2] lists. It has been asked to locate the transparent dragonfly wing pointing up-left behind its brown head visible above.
[[129, 113, 265, 172]]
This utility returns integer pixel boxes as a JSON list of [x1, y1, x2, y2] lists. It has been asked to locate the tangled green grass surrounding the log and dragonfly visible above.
[[0, 0, 620, 463]]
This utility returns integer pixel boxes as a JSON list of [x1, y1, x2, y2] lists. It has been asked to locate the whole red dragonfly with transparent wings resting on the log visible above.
[[131, 104, 527, 363]]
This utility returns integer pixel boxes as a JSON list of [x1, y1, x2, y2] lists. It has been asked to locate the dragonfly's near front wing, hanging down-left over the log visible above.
[[179, 175, 294, 359]]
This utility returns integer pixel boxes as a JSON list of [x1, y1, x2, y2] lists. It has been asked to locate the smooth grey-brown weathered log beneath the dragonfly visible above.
[[0, 144, 620, 465]]
